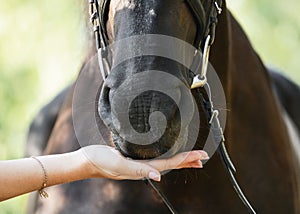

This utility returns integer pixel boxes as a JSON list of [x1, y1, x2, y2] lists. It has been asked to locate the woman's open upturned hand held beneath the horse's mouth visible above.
[[80, 145, 209, 181]]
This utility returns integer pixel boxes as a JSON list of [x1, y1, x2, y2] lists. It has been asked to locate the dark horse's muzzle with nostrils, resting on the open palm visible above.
[[98, 73, 189, 159]]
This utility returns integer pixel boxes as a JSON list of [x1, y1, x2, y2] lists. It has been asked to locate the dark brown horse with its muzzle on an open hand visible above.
[[27, 0, 300, 214]]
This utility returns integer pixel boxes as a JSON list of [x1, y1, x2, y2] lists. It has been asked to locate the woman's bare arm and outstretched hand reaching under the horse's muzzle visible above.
[[0, 145, 209, 201]]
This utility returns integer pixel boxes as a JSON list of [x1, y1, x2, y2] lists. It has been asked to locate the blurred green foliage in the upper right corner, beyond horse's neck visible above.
[[227, 0, 300, 84]]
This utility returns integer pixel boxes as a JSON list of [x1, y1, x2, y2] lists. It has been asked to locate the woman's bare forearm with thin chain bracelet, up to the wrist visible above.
[[0, 150, 91, 201]]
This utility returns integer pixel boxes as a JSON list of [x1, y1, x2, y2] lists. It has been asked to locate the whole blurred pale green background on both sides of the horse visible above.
[[0, 0, 300, 214]]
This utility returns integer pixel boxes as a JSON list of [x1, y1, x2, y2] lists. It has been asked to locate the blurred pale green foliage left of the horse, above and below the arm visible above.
[[0, 0, 85, 214]]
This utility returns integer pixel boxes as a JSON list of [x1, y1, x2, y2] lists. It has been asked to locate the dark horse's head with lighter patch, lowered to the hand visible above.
[[99, 0, 216, 159]]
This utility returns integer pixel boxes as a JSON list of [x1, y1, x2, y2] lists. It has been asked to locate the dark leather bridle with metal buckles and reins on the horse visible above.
[[89, 0, 256, 214]]
